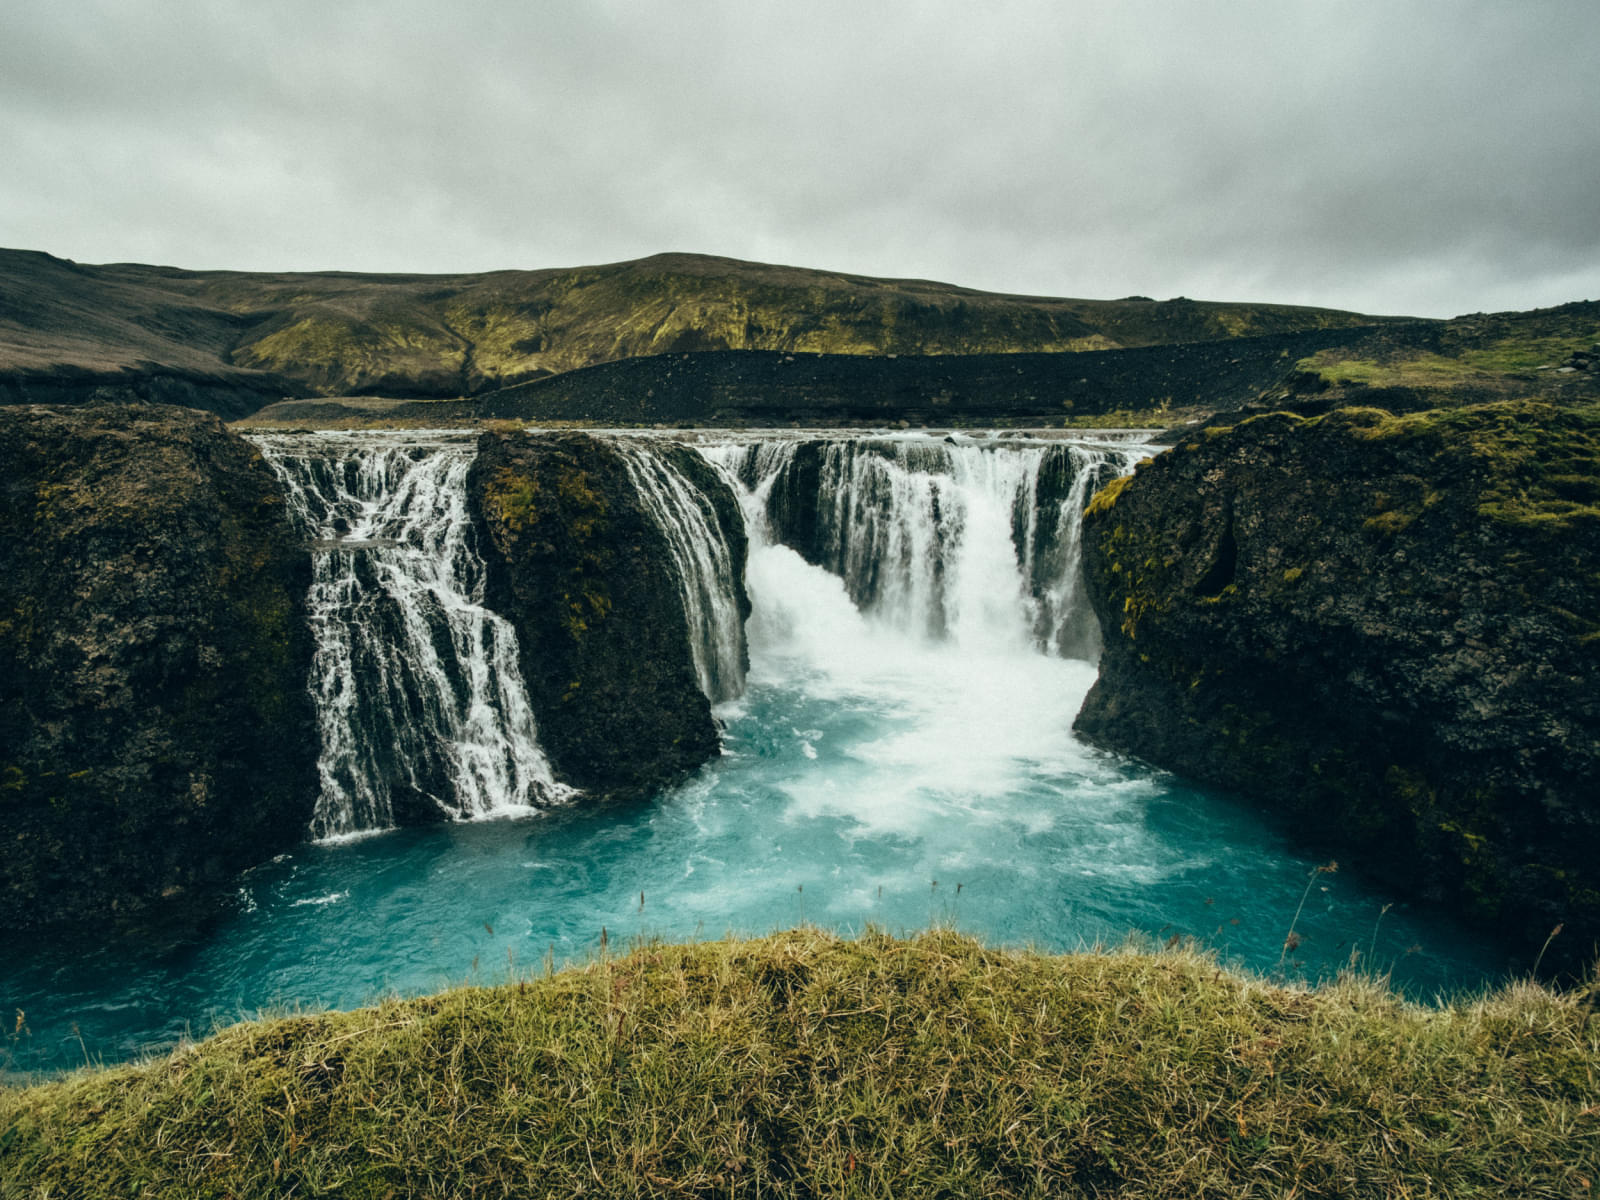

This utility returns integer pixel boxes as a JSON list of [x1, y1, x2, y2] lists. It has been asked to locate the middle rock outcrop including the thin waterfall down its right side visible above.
[[467, 434, 749, 795]]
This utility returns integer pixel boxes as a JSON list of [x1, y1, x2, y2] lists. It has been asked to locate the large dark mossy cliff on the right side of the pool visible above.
[[1077, 400, 1600, 965]]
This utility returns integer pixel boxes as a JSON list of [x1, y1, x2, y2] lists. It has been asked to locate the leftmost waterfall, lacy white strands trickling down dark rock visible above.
[[251, 432, 571, 838]]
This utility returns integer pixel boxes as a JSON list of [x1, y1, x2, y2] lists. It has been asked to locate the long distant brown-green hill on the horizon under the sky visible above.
[[0, 250, 1395, 416]]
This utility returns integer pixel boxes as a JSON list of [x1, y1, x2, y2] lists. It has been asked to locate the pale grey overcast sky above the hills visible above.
[[0, 0, 1600, 317]]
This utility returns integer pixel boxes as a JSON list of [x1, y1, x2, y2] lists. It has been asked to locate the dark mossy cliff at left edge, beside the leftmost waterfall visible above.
[[0, 405, 317, 928]]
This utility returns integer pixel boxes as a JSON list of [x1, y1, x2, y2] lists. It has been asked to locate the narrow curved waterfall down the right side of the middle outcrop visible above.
[[611, 437, 746, 704]]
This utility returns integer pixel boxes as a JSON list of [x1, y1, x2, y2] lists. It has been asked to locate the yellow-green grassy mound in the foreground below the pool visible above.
[[0, 930, 1600, 1200]]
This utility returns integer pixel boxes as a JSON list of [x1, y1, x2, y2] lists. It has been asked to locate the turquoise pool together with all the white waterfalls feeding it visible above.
[[0, 434, 1502, 1074]]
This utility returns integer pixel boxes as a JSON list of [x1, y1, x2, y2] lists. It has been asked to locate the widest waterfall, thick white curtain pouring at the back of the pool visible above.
[[702, 435, 1150, 661]]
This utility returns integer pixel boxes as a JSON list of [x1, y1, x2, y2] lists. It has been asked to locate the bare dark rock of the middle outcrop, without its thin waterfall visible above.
[[467, 432, 749, 795]]
